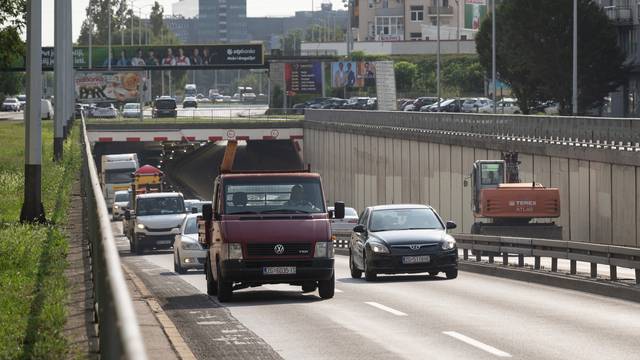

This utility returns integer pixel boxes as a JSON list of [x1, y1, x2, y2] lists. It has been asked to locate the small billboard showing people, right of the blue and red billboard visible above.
[[331, 61, 376, 88]]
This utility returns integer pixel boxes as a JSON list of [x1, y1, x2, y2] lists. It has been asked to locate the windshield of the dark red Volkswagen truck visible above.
[[224, 177, 326, 215]]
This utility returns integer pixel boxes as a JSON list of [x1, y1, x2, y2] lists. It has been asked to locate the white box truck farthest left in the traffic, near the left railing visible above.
[[100, 154, 140, 209]]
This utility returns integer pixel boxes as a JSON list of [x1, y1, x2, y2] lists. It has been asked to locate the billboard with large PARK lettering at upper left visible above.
[[75, 71, 145, 103]]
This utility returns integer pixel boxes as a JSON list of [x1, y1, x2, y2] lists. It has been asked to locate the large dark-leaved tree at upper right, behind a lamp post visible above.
[[476, 0, 628, 114]]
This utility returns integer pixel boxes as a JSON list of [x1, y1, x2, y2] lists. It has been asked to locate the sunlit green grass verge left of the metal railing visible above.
[[0, 122, 81, 359]]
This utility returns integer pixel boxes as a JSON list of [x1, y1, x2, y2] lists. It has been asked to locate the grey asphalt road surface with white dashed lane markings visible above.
[[114, 223, 640, 359]]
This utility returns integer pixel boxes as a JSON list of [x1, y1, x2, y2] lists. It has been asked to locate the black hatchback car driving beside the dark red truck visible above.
[[349, 205, 458, 281]]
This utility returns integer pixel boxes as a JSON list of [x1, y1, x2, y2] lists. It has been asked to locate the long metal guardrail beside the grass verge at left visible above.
[[81, 114, 147, 360]]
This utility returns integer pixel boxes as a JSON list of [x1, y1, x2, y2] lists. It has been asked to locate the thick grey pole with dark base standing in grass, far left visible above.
[[20, 0, 45, 222]]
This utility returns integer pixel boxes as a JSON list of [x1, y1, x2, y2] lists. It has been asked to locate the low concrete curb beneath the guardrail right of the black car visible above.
[[458, 260, 640, 303]]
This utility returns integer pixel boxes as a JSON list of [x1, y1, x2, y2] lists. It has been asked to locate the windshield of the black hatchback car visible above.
[[369, 208, 444, 232]]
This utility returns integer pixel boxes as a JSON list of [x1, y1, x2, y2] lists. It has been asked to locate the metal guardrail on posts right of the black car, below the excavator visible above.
[[454, 234, 640, 284]]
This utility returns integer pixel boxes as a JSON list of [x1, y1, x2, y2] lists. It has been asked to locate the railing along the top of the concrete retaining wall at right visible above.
[[305, 110, 640, 149]]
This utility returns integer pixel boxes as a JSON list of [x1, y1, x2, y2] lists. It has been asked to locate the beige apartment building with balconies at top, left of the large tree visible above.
[[353, 0, 468, 41]]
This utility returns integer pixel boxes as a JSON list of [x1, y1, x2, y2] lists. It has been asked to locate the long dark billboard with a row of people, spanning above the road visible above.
[[12, 44, 264, 70]]
